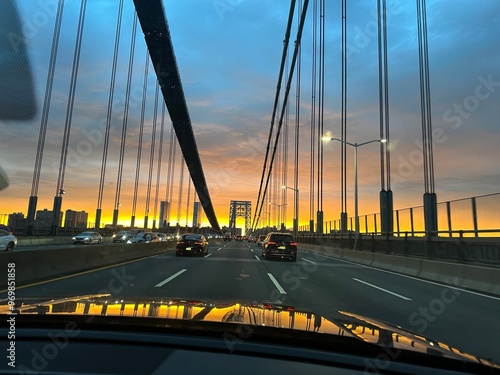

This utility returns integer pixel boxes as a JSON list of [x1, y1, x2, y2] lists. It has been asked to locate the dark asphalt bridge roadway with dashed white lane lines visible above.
[[0, 240, 500, 362]]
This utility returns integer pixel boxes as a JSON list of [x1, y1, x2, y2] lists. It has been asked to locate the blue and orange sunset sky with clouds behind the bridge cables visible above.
[[0, 0, 500, 232]]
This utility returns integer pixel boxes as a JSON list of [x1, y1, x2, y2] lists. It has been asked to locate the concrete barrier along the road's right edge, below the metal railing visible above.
[[299, 244, 500, 296]]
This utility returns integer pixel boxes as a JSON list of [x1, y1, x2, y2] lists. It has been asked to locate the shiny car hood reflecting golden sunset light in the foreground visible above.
[[0, 294, 500, 369]]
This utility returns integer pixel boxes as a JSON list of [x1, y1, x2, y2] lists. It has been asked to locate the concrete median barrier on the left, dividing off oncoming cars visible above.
[[0, 242, 175, 289]]
